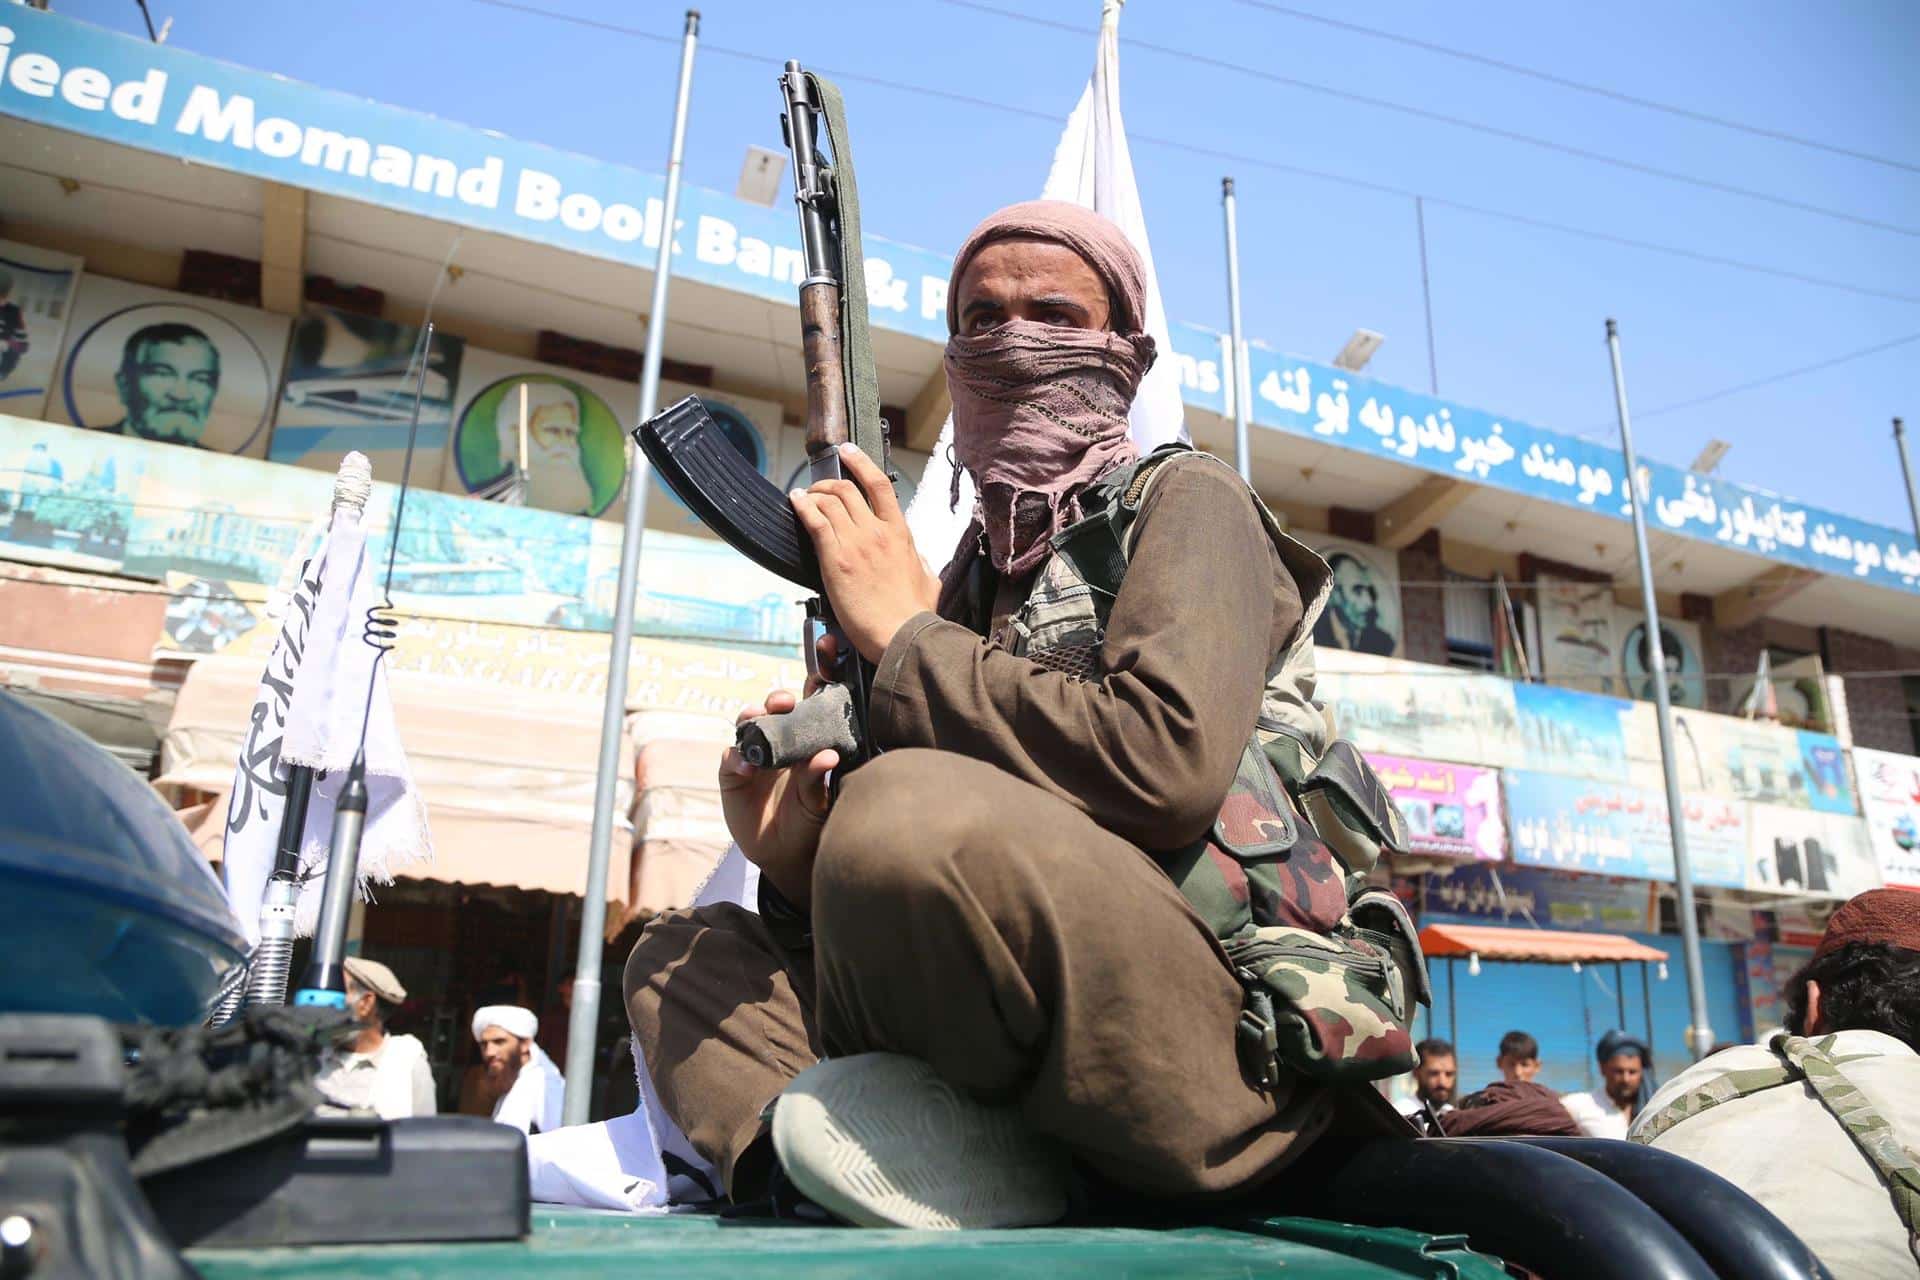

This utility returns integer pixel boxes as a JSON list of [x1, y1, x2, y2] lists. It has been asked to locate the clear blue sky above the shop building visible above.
[[56, 0, 1920, 530]]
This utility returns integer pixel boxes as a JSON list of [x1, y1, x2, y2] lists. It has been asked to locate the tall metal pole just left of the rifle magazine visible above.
[[561, 10, 701, 1125]]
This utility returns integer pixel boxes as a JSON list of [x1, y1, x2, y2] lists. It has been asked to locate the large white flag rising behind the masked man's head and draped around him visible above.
[[526, 0, 1188, 1213]]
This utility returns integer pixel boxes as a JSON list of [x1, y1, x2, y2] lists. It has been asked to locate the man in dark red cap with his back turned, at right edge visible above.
[[1632, 889, 1920, 1276]]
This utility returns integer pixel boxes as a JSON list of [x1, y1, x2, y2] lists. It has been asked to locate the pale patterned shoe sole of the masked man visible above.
[[774, 1054, 1068, 1230]]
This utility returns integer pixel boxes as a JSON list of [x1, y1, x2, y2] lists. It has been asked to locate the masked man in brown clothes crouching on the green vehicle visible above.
[[624, 201, 1336, 1226]]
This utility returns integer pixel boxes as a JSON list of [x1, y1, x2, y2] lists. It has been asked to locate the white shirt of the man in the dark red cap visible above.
[[1642, 1031, 1920, 1276]]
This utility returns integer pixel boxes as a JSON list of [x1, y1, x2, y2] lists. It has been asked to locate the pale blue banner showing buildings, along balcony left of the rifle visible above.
[[0, 416, 801, 645]]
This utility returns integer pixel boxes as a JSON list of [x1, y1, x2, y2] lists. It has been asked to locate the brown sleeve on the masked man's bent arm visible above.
[[872, 459, 1302, 850]]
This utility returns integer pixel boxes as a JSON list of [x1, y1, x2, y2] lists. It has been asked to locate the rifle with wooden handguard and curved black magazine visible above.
[[634, 61, 891, 777]]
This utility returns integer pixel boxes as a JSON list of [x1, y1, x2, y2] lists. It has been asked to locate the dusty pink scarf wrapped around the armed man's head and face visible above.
[[947, 200, 1154, 587]]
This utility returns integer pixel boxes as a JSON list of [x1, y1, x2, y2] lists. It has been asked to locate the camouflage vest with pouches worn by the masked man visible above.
[[1002, 445, 1428, 1084]]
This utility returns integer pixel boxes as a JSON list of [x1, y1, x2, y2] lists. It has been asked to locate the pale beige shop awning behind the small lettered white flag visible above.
[[154, 658, 634, 902]]
